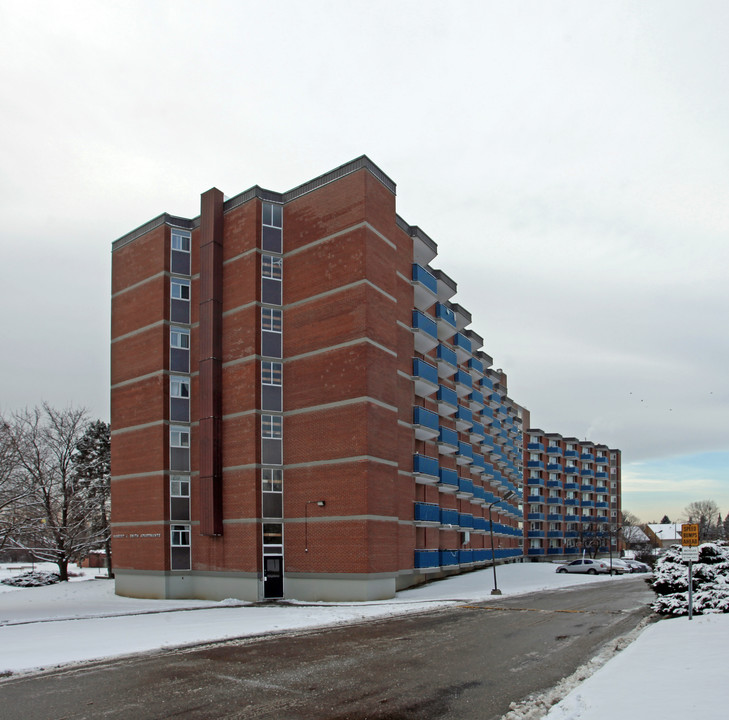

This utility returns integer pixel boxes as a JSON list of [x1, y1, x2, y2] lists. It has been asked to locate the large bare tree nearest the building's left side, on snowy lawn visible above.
[[4, 403, 100, 580]]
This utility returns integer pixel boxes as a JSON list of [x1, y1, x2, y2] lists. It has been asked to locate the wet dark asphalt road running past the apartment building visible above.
[[0, 576, 653, 720]]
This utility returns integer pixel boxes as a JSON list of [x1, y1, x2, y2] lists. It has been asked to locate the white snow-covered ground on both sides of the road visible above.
[[0, 563, 729, 720]]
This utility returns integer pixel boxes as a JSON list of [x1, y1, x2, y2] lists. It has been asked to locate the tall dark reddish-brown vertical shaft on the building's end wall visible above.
[[198, 188, 223, 535]]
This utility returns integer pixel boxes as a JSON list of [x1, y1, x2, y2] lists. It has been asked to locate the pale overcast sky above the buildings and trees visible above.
[[0, 0, 729, 520]]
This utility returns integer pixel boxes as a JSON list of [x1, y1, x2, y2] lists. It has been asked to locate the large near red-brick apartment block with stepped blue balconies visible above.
[[111, 156, 524, 601]]
